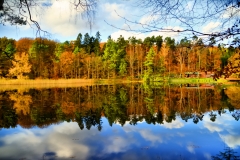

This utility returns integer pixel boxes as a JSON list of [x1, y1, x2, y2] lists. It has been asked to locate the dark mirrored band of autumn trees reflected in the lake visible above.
[[0, 84, 240, 130]]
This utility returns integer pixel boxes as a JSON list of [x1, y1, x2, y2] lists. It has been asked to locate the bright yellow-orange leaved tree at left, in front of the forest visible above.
[[9, 52, 32, 79]]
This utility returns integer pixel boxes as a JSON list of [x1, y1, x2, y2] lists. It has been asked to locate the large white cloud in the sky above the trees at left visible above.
[[28, 0, 89, 36]]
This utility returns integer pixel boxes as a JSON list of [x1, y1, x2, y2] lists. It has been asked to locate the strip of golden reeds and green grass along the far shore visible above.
[[0, 78, 235, 90]]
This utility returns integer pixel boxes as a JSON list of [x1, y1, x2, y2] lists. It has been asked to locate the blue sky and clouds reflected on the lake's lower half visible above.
[[0, 110, 240, 160]]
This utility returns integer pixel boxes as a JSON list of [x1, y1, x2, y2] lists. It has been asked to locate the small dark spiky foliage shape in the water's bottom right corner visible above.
[[212, 147, 240, 160]]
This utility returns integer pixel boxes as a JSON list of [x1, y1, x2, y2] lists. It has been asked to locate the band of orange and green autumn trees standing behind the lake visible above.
[[0, 32, 240, 80]]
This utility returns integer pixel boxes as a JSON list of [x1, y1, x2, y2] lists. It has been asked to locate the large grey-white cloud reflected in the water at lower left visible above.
[[0, 122, 90, 159]]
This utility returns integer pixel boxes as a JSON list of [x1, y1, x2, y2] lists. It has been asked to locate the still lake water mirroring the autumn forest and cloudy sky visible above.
[[0, 84, 240, 160]]
